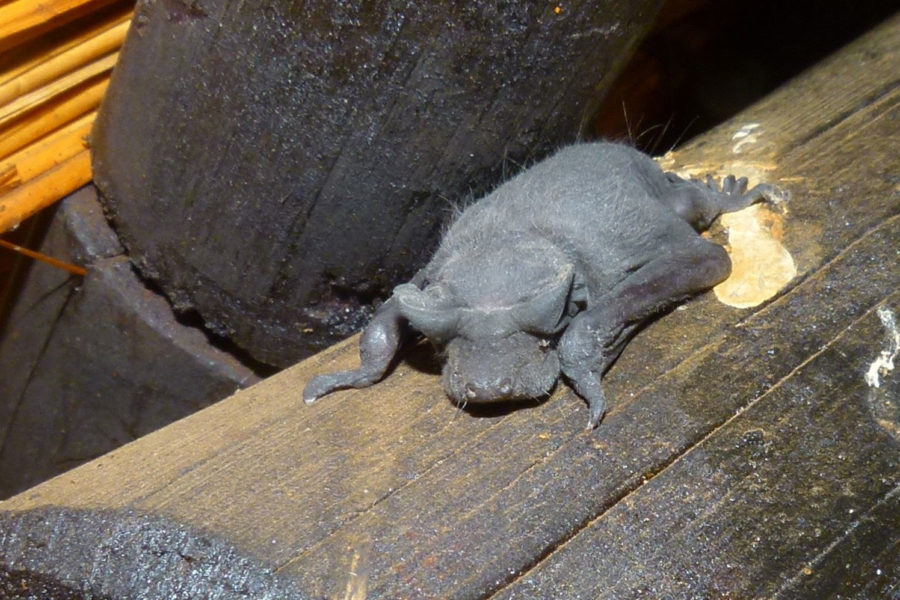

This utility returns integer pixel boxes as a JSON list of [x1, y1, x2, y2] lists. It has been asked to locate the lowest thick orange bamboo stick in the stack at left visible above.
[[0, 150, 91, 232]]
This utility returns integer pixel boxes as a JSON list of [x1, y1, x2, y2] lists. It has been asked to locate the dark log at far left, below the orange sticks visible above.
[[0, 187, 257, 497]]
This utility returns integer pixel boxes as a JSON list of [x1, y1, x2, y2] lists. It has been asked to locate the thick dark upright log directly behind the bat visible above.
[[94, 0, 661, 366]]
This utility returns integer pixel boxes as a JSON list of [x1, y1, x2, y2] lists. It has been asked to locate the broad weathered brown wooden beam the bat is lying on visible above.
[[0, 10, 900, 598]]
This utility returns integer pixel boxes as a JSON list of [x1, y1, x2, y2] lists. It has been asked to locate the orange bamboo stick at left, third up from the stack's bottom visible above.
[[0, 77, 109, 160]]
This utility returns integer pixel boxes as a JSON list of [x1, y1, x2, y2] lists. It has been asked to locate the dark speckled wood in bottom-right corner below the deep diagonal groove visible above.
[[495, 251, 900, 600]]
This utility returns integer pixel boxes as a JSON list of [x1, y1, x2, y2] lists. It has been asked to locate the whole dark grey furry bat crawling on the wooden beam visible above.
[[303, 142, 772, 428]]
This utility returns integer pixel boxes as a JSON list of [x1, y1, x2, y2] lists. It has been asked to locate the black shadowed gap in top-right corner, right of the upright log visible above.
[[594, 0, 900, 154]]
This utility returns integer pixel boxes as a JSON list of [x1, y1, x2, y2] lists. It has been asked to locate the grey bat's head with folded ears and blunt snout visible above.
[[394, 258, 574, 404]]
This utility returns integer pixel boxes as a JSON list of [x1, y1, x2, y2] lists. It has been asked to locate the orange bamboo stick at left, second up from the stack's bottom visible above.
[[0, 111, 97, 194]]
